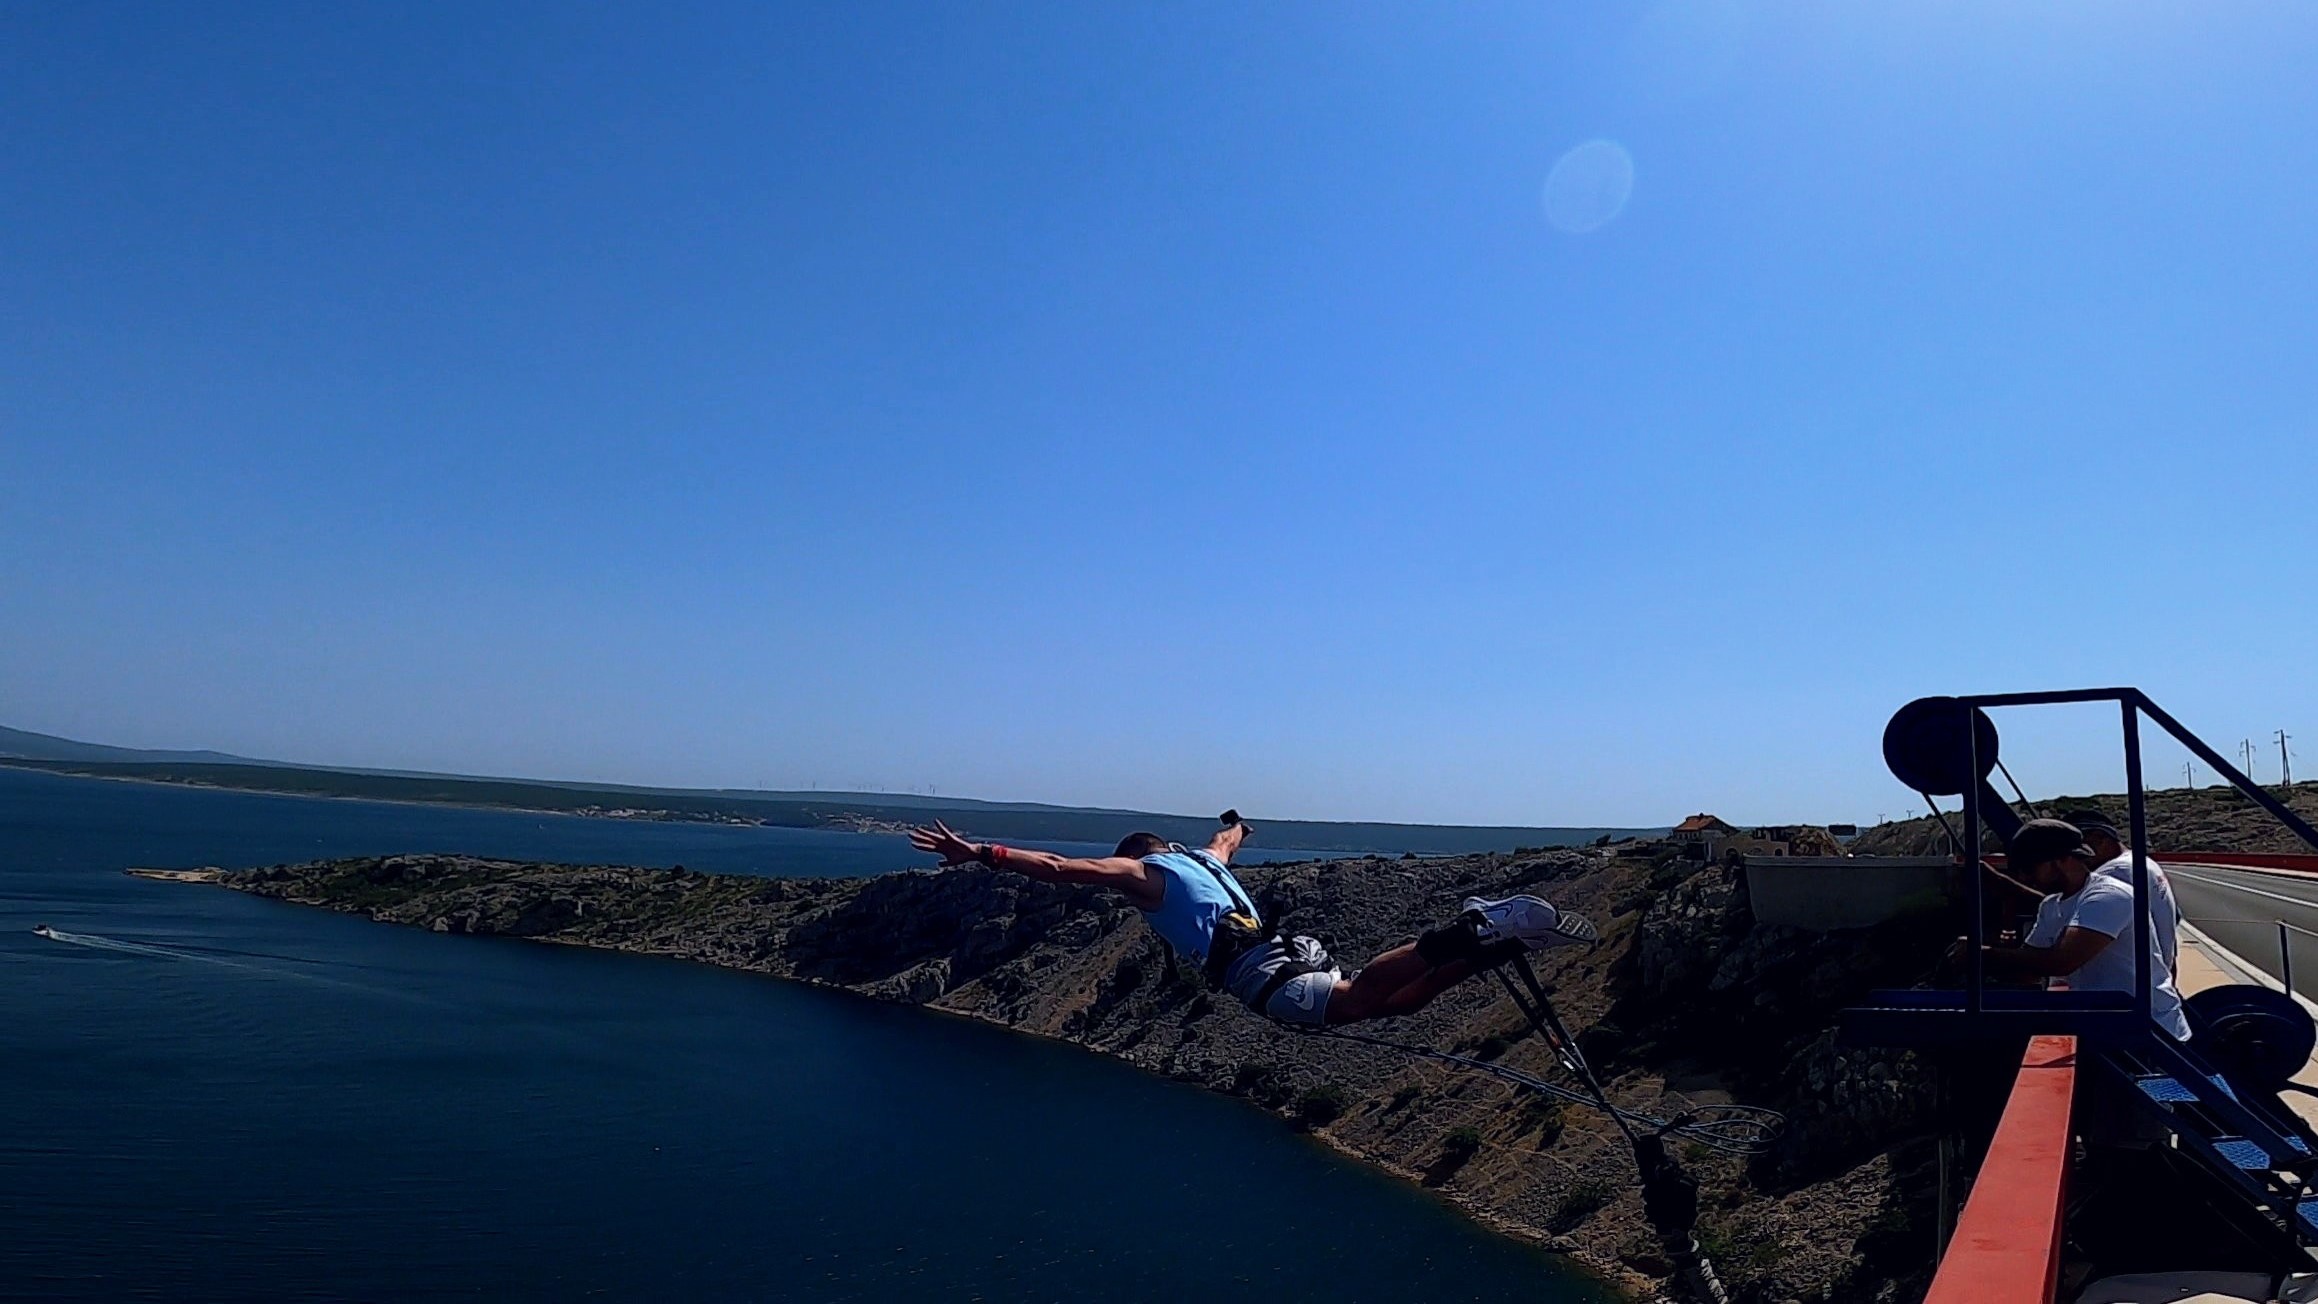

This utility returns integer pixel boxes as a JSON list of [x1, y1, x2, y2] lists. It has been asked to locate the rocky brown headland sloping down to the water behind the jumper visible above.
[[185, 850, 1974, 1304]]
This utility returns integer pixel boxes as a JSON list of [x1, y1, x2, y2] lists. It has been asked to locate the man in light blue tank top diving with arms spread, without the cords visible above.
[[909, 811, 1599, 1026]]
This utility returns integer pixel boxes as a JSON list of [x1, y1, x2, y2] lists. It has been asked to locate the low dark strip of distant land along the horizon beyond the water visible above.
[[0, 730, 1664, 855]]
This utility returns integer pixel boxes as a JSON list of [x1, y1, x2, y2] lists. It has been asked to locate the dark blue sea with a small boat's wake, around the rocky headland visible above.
[[0, 769, 1602, 1304]]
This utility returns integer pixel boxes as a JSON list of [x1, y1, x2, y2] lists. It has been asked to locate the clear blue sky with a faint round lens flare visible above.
[[0, 2, 2318, 825]]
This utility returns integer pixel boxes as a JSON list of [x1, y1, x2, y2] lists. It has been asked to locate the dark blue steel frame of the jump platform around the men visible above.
[[1843, 688, 2318, 1045]]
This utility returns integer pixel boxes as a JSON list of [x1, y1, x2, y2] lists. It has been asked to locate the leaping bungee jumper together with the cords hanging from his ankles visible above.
[[909, 811, 1785, 1304]]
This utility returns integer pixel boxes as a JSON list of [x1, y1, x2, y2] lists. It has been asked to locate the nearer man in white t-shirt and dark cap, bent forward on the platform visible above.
[[1987, 820, 2188, 1040]]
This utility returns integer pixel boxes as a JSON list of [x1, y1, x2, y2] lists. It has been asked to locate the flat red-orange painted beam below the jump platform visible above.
[[1924, 1038, 2077, 1304]]
